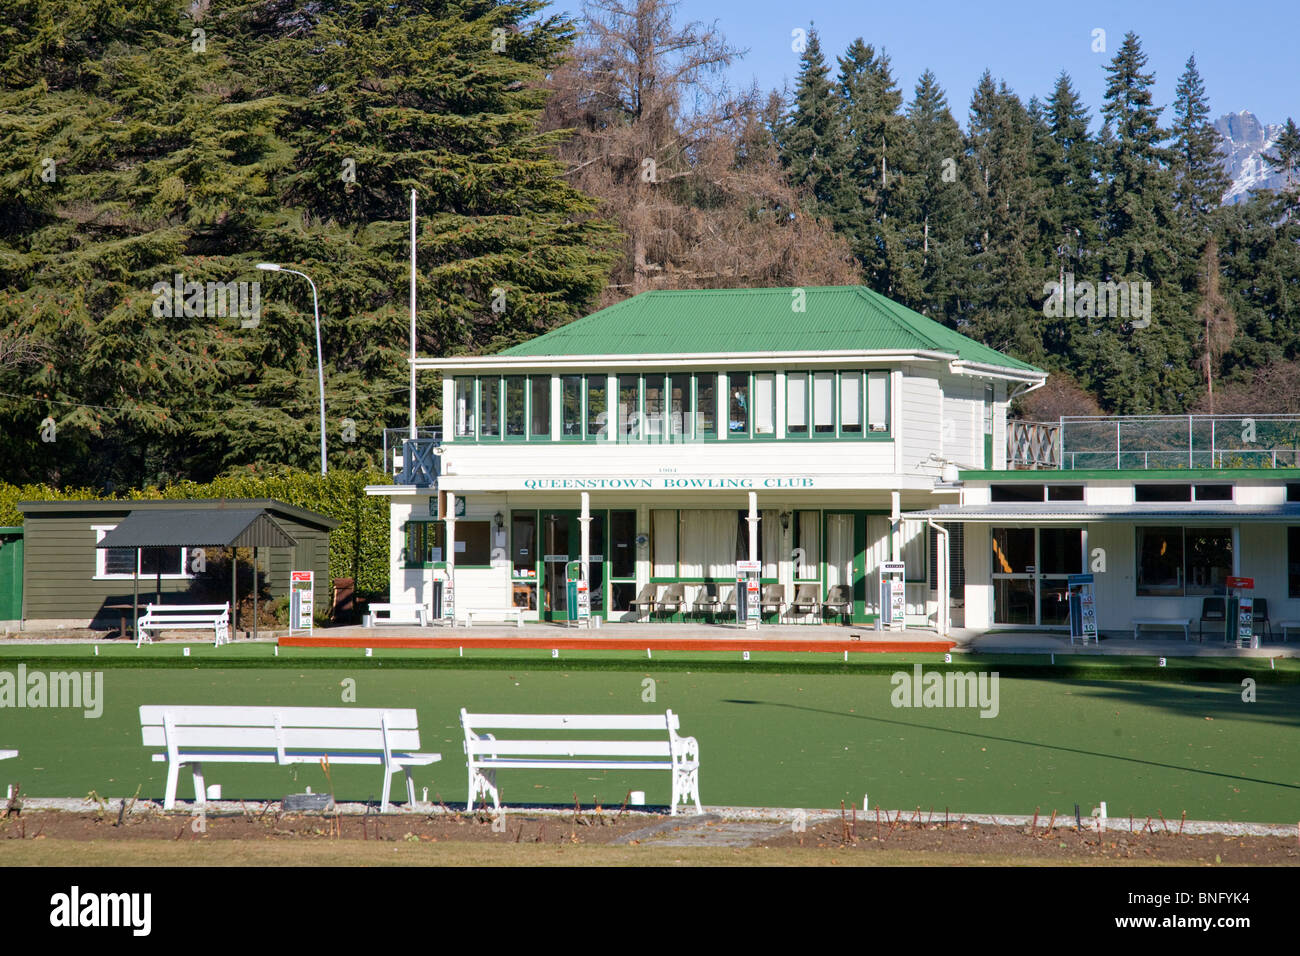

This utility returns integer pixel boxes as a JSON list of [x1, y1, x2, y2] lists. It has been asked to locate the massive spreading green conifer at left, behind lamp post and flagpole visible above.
[[0, 0, 616, 485]]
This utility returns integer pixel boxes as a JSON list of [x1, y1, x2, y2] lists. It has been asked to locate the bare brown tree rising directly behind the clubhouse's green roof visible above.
[[546, 0, 858, 302]]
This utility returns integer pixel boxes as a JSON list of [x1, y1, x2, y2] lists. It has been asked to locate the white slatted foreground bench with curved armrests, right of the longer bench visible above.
[[460, 708, 703, 816]]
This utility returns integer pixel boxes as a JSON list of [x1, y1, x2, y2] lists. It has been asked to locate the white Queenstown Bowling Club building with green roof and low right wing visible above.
[[368, 286, 1300, 632]]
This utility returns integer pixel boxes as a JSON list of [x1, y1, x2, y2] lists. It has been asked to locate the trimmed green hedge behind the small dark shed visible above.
[[0, 468, 389, 592]]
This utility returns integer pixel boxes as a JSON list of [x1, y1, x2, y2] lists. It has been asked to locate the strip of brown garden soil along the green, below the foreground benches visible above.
[[0, 804, 1300, 866]]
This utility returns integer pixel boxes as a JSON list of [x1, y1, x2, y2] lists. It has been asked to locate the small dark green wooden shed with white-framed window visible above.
[[18, 498, 338, 628]]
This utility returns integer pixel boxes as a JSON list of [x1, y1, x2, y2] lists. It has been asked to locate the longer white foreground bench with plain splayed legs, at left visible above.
[[140, 705, 442, 813]]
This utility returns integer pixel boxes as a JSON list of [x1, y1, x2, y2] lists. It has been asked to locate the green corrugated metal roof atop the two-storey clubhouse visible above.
[[501, 286, 1041, 372]]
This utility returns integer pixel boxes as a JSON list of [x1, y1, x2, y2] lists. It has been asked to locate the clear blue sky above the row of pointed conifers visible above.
[[566, 0, 1300, 129]]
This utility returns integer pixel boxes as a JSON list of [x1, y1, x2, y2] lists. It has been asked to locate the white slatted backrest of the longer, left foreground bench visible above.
[[140, 705, 420, 757]]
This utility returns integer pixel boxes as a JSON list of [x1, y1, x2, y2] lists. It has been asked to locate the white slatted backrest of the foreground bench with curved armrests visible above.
[[460, 708, 680, 757]]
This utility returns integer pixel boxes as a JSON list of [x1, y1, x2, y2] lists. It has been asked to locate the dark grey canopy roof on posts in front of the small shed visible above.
[[96, 509, 298, 548]]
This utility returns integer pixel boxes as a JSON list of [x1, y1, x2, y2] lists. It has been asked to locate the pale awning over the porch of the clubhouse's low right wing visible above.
[[904, 502, 1300, 524]]
